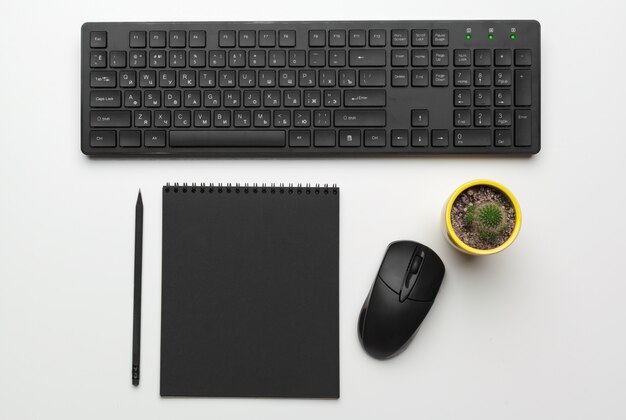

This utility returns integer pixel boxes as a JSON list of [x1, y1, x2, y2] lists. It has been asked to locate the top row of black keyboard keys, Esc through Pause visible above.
[[90, 29, 449, 48]]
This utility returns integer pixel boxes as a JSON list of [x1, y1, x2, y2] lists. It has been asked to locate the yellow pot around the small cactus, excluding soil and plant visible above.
[[443, 179, 522, 256]]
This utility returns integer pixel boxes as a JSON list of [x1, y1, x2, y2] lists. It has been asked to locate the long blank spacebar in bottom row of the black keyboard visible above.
[[170, 130, 285, 147]]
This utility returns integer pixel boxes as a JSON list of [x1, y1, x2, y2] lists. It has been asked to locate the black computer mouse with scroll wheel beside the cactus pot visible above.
[[358, 241, 446, 359]]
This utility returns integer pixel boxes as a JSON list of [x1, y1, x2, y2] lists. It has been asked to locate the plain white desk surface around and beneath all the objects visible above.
[[0, 0, 626, 420]]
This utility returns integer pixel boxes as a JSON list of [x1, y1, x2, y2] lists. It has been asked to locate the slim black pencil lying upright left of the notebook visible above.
[[131, 190, 143, 386]]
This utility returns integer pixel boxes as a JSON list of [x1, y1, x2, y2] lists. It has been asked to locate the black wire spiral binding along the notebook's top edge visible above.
[[163, 182, 339, 195]]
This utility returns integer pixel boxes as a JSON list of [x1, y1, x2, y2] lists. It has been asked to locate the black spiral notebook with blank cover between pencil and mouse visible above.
[[161, 185, 339, 398]]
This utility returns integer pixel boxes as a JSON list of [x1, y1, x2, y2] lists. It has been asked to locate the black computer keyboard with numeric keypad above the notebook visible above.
[[81, 21, 541, 157]]
